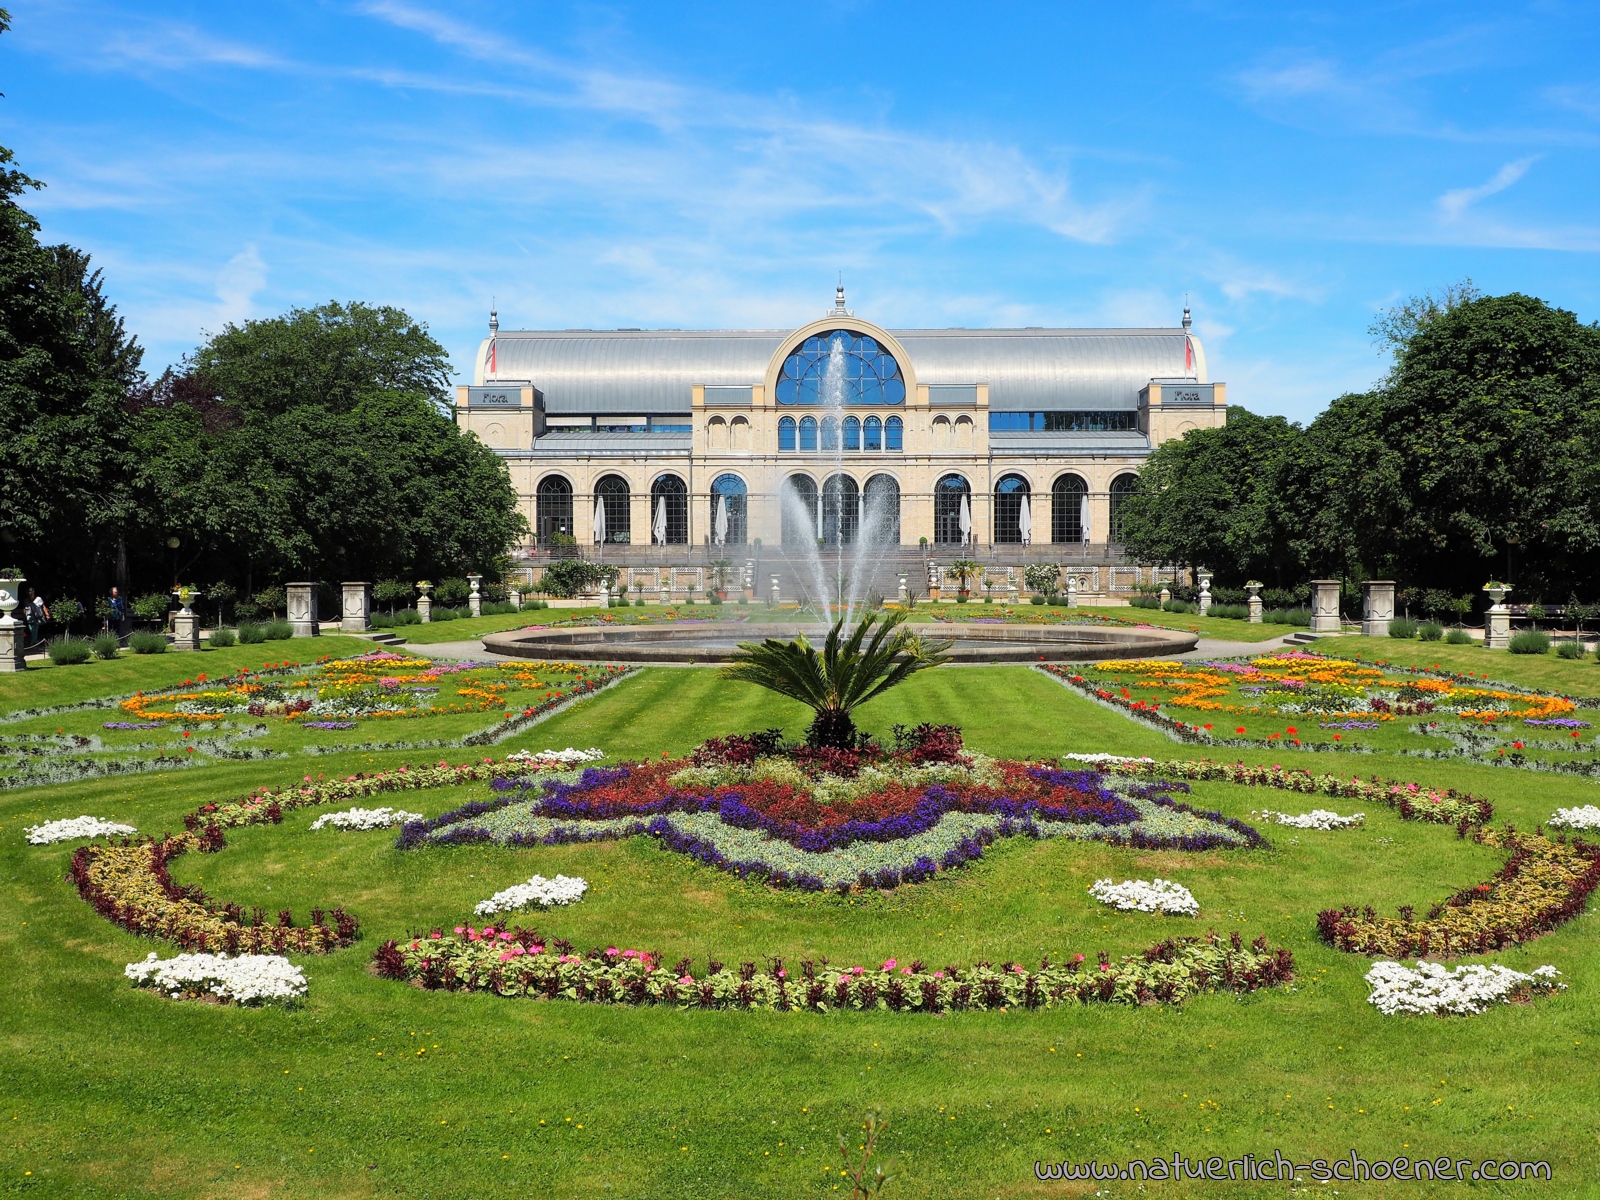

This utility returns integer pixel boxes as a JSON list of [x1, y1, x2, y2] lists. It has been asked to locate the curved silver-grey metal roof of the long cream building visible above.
[[474, 320, 1206, 414]]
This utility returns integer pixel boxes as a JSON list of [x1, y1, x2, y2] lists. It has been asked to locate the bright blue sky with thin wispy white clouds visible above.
[[0, 0, 1600, 419]]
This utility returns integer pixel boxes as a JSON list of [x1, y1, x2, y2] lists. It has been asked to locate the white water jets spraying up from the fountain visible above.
[[782, 333, 893, 629]]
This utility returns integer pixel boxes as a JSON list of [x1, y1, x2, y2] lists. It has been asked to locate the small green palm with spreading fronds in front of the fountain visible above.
[[722, 613, 952, 750]]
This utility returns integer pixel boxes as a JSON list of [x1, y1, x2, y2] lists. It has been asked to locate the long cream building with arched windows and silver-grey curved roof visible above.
[[456, 288, 1226, 557]]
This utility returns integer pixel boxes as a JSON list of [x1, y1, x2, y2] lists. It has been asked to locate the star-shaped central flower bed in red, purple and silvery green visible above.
[[397, 726, 1261, 891]]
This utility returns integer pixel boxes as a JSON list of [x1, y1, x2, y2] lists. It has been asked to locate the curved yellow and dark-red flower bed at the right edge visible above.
[[1317, 830, 1600, 958]]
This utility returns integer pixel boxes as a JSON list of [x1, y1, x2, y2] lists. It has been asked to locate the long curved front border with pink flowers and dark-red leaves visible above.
[[373, 926, 1294, 1013]]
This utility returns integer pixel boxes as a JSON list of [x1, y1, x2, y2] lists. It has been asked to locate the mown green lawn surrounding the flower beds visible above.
[[0, 659, 1600, 1198]]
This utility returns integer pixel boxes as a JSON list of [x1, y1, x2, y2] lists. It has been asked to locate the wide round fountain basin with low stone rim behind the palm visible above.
[[483, 621, 1200, 662]]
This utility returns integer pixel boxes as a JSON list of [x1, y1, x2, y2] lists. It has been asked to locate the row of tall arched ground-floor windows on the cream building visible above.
[[534, 473, 1138, 546]]
